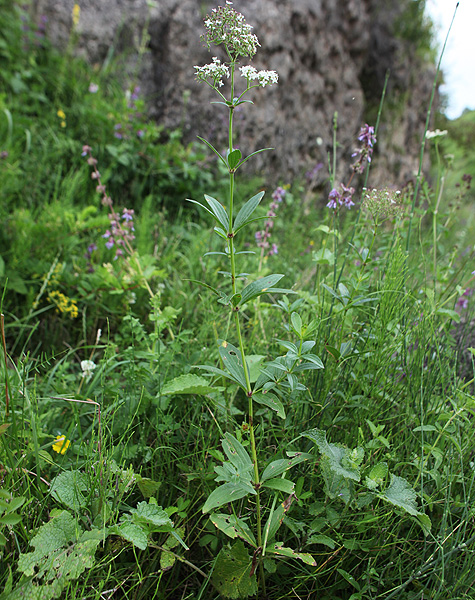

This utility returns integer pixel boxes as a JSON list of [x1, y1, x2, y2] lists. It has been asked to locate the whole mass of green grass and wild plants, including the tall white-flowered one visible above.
[[0, 2, 475, 600]]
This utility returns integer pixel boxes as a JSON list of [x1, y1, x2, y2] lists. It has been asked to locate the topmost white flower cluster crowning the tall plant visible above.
[[204, 2, 260, 58]]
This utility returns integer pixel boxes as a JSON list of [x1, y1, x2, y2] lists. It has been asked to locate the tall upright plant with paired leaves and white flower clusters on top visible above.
[[190, 2, 323, 597]]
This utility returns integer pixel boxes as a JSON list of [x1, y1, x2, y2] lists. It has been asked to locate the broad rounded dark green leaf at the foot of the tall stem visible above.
[[211, 541, 257, 598]]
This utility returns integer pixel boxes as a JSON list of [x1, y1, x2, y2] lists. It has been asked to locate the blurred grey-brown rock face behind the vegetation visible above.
[[31, 0, 435, 186]]
